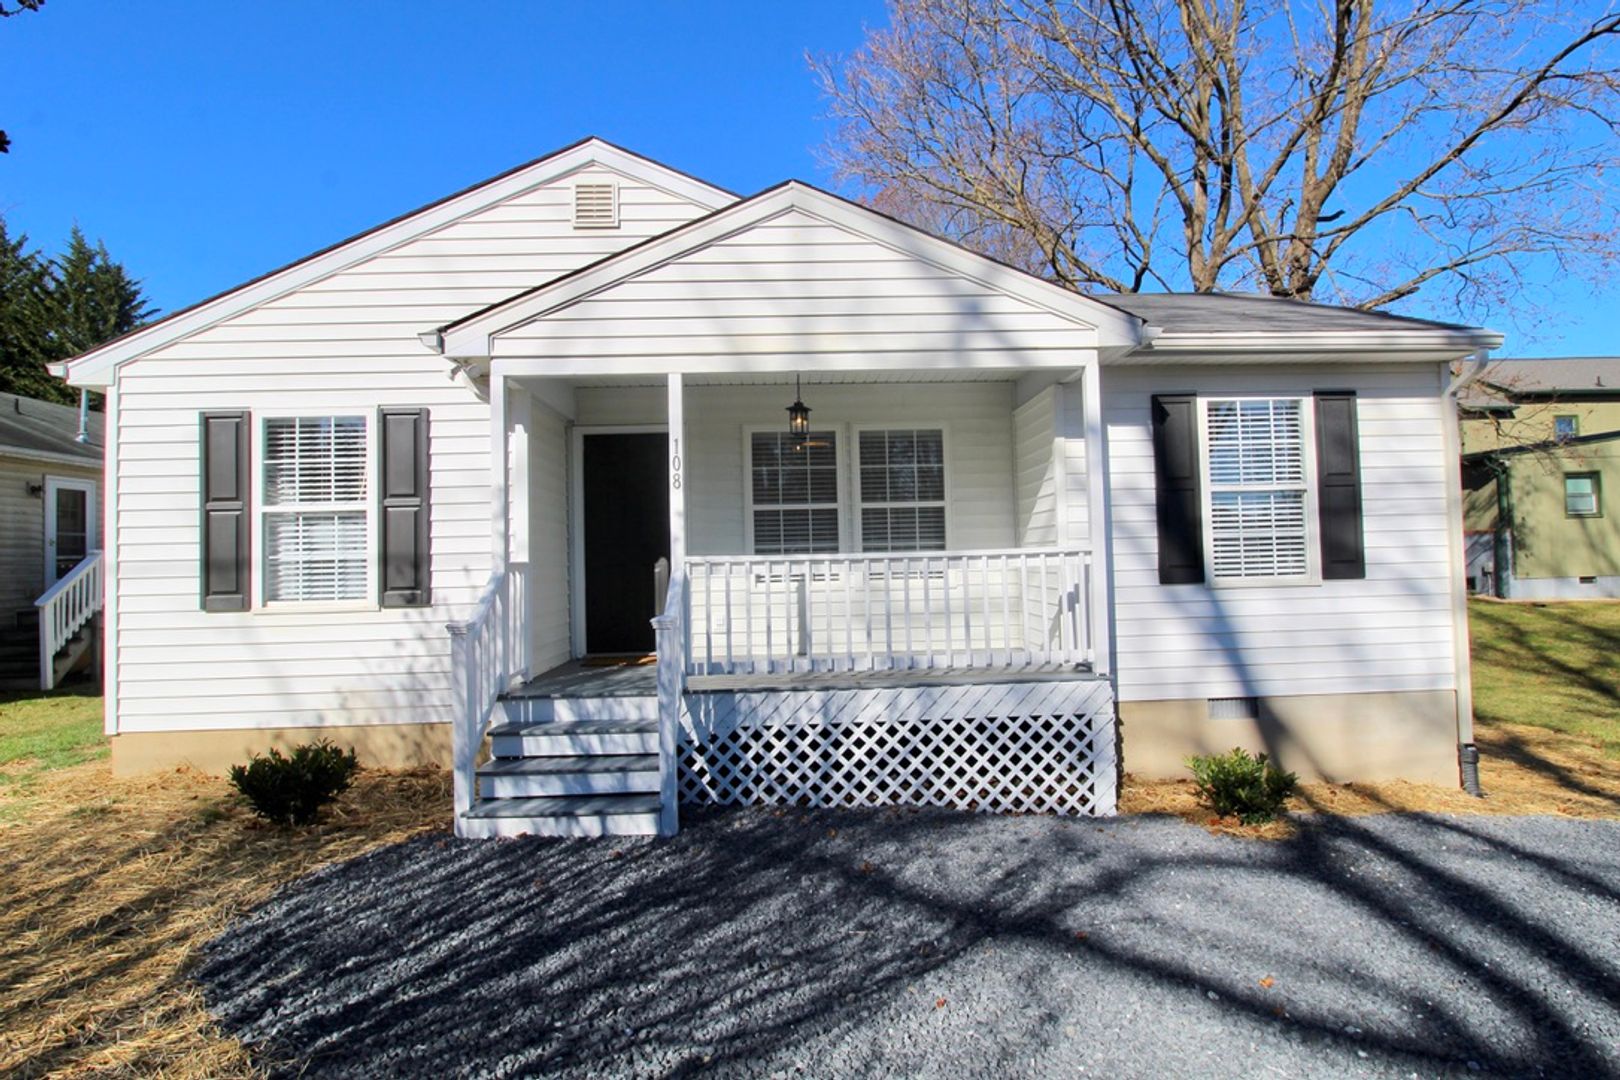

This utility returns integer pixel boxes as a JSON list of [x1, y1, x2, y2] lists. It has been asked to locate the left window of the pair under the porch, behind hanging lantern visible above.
[[748, 431, 838, 555]]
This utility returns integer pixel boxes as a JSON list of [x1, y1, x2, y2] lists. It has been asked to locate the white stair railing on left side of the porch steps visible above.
[[446, 563, 528, 831]]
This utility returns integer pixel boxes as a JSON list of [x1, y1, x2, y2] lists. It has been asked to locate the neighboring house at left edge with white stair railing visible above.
[[0, 393, 102, 688]]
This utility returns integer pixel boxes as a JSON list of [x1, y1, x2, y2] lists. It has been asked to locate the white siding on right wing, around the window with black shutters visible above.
[[1101, 366, 1455, 701]]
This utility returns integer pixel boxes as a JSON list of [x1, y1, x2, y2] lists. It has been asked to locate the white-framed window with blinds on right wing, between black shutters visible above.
[[1202, 398, 1311, 581]]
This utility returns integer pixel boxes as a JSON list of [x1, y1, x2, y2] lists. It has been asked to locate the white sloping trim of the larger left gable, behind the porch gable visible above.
[[50, 136, 737, 387]]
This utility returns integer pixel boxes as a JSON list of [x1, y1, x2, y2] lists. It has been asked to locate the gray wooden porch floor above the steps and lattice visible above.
[[507, 661, 1097, 698]]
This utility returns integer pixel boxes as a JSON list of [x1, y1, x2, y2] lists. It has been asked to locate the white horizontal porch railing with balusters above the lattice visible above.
[[685, 547, 1095, 675]]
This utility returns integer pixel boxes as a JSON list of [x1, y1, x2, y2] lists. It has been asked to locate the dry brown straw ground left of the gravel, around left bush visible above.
[[0, 761, 450, 1077]]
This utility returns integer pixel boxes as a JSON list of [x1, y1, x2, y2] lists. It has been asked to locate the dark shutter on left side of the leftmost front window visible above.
[[199, 413, 251, 612]]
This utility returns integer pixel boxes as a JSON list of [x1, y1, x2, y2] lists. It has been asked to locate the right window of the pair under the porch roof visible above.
[[859, 427, 944, 551]]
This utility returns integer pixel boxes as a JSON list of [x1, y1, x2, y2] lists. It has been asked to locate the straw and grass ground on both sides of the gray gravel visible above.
[[0, 602, 1620, 1077]]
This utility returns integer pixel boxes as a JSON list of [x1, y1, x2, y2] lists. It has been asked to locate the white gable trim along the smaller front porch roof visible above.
[[421, 180, 1142, 359]]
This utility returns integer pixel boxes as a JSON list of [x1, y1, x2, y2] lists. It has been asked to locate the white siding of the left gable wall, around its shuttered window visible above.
[[113, 167, 705, 730]]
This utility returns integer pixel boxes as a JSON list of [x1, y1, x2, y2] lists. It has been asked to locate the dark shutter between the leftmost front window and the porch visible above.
[[377, 408, 429, 607]]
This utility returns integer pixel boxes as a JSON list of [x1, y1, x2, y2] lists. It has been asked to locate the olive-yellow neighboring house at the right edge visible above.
[[1458, 356, 1620, 599]]
